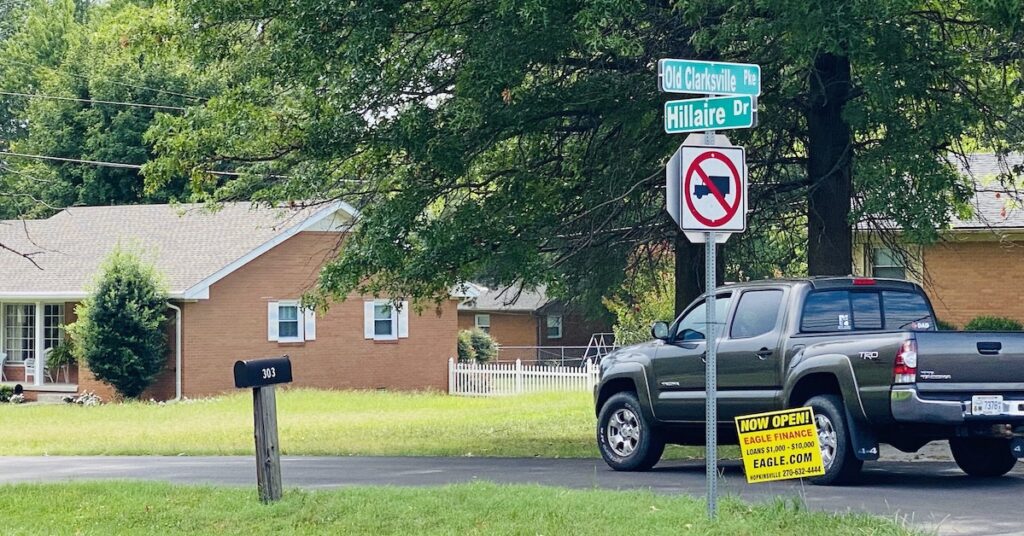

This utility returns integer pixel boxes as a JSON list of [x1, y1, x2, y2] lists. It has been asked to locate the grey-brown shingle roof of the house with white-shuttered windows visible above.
[[0, 203, 333, 297]]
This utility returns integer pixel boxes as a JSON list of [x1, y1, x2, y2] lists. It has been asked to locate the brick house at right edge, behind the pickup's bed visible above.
[[854, 154, 1024, 328]]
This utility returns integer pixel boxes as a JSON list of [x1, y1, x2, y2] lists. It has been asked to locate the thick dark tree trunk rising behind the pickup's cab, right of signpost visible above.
[[807, 53, 853, 276]]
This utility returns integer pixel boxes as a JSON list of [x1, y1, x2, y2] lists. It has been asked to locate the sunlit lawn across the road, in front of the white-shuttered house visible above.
[[0, 389, 738, 458]]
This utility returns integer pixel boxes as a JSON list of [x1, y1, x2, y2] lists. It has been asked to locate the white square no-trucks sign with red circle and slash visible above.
[[677, 146, 746, 233]]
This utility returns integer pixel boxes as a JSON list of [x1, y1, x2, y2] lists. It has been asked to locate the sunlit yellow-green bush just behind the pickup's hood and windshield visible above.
[[604, 261, 675, 346]]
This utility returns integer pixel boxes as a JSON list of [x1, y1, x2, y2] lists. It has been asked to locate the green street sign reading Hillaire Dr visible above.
[[665, 95, 756, 134]]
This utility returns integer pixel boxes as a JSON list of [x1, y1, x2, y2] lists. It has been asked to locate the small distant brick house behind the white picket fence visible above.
[[459, 285, 612, 361]]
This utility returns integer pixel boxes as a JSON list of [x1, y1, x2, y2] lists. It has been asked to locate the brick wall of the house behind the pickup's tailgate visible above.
[[924, 241, 1024, 328]]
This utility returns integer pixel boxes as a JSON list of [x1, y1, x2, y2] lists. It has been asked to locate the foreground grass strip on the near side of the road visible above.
[[0, 482, 913, 536]]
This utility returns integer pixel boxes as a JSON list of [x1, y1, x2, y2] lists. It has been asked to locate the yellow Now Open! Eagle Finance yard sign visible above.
[[736, 408, 825, 484]]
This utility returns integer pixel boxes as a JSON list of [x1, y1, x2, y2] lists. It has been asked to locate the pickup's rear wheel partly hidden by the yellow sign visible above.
[[805, 395, 864, 486]]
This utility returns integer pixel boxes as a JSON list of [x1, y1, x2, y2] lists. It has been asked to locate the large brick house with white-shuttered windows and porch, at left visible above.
[[0, 203, 458, 400]]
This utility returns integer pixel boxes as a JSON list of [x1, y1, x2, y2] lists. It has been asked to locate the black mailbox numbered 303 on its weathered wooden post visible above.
[[234, 356, 292, 502]]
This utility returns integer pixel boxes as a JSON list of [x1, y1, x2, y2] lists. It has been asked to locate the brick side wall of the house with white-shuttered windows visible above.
[[182, 232, 458, 398]]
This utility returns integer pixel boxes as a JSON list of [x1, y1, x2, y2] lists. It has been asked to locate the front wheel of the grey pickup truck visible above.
[[597, 393, 665, 470]]
